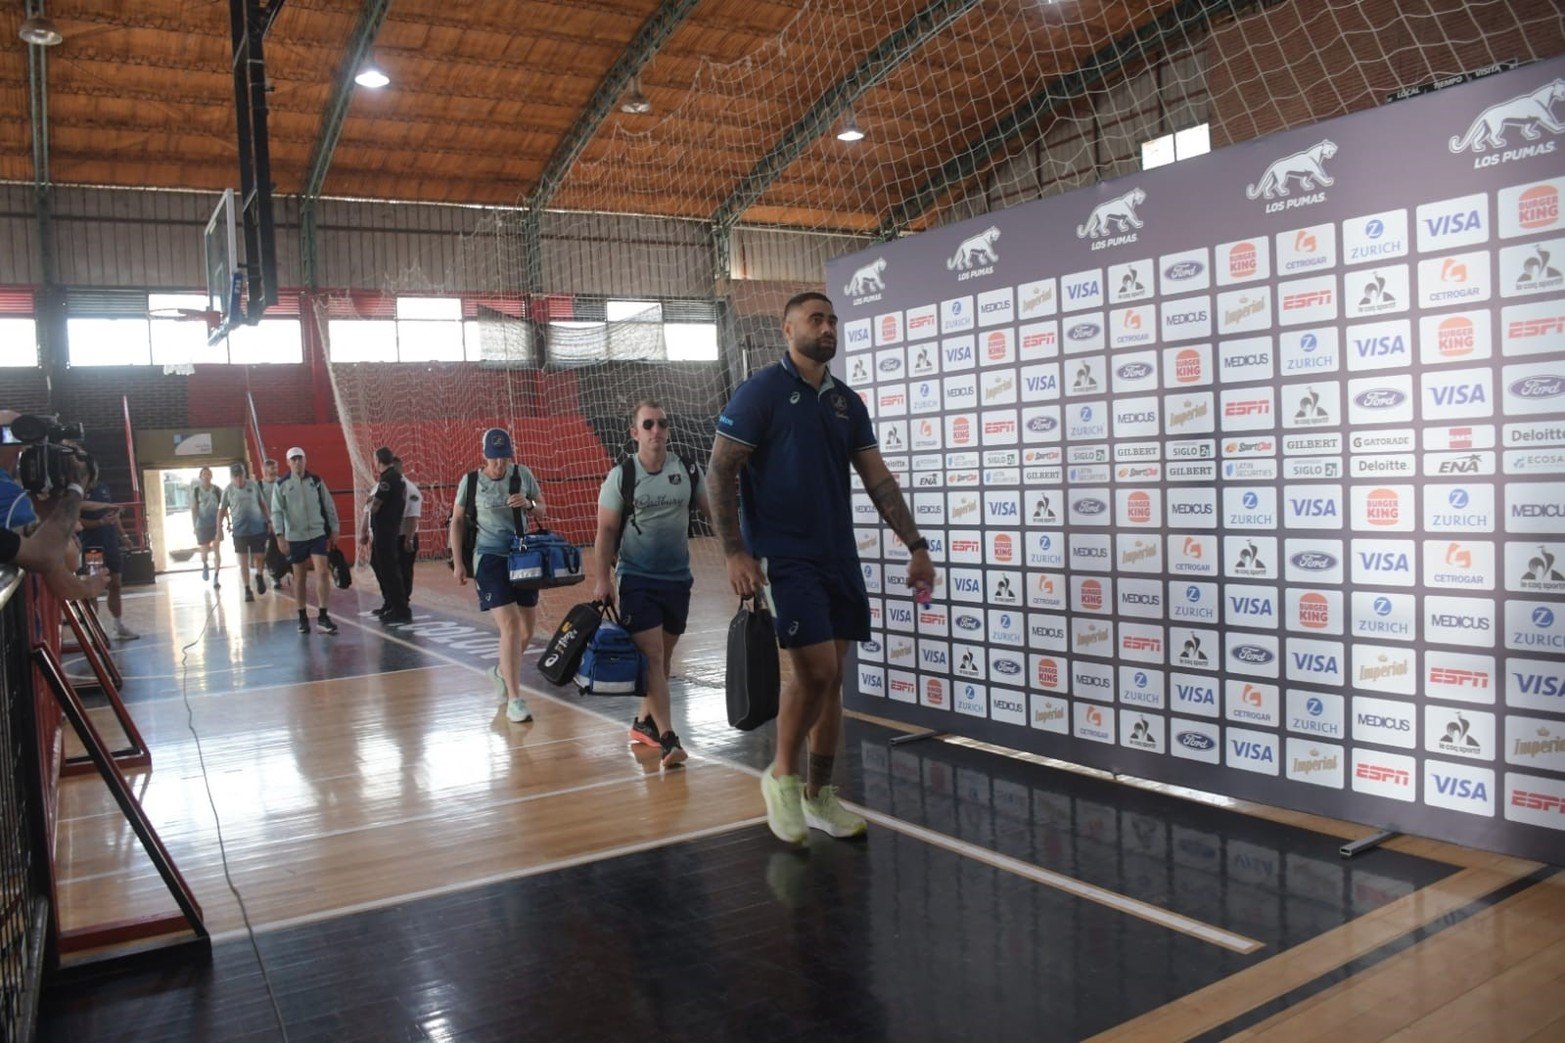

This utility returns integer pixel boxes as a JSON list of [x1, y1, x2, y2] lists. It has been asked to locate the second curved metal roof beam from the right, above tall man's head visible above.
[[712, 0, 978, 227]]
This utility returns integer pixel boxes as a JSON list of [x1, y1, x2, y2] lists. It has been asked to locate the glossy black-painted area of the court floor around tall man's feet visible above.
[[39, 588, 1452, 1041]]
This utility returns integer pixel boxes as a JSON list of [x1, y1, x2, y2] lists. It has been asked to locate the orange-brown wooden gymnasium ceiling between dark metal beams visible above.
[[0, 0, 1188, 229]]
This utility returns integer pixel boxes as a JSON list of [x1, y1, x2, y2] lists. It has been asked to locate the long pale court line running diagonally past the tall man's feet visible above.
[[343, 617, 1266, 954]]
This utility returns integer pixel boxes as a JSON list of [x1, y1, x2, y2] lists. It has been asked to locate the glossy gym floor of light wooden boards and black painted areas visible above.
[[27, 554, 1565, 1043]]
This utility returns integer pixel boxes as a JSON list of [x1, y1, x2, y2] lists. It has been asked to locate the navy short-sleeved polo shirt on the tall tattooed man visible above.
[[717, 354, 878, 561]]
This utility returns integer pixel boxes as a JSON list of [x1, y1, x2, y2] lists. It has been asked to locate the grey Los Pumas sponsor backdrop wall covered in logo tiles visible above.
[[826, 60, 1565, 861]]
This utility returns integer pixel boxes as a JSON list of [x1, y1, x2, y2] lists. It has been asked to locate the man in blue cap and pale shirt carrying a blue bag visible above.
[[449, 428, 543, 724]]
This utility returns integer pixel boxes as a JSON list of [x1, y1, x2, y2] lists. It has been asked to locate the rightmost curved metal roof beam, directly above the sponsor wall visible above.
[[875, 0, 1283, 240]]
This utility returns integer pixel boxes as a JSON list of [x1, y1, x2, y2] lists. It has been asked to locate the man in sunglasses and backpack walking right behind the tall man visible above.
[[593, 398, 711, 767]]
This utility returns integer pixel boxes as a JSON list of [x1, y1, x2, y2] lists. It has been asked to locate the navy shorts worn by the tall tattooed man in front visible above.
[[761, 558, 870, 648]]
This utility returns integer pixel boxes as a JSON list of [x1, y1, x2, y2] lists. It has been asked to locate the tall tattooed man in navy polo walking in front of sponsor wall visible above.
[[709, 293, 934, 844]]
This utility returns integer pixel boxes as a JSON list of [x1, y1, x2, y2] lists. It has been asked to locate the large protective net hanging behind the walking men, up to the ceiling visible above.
[[330, 0, 1565, 558]]
